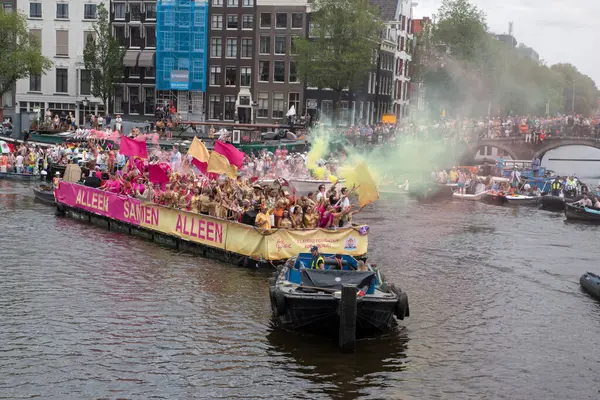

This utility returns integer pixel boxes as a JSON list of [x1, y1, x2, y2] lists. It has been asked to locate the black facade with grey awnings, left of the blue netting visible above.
[[109, 0, 157, 120]]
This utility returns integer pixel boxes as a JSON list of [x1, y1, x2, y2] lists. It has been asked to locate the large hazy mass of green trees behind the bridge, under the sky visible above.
[[413, 0, 597, 117]]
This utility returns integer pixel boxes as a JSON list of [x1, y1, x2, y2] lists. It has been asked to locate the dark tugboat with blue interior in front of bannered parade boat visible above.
[[269, 253, 410, 346]]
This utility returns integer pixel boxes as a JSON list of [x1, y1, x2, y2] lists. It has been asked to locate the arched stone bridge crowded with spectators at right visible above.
[[460, 136, 600, 163]]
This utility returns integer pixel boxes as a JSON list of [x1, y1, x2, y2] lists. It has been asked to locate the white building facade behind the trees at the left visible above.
[[15, 0, 106, 124]]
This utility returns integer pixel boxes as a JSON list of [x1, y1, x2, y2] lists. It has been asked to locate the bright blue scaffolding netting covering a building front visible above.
[[156, 0, 208, 92]]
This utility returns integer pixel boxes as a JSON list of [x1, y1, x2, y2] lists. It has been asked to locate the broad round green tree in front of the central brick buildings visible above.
[[294, 0, 383, 122]]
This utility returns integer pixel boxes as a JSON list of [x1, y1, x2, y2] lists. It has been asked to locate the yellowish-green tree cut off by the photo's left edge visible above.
[[0, 7, 52, 100]]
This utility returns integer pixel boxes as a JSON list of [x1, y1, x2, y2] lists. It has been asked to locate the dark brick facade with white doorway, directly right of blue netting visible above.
[[205, 0, 257, 123]]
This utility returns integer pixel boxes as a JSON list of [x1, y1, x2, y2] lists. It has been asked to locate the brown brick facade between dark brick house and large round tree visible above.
[[254, 0, 307, 123]]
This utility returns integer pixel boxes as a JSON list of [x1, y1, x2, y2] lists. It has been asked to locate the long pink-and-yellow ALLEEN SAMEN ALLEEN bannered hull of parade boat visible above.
[[54, 183, 369, 268]]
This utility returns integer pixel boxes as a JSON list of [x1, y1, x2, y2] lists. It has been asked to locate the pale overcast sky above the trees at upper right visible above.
[[413, 0, 600, 86]]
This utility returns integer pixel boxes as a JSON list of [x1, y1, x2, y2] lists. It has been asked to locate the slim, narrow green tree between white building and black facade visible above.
[[83, 3, 125, 115]]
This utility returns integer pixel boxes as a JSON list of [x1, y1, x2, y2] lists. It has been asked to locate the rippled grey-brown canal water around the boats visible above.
[[0, 181, 600, 399]]
